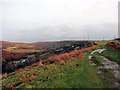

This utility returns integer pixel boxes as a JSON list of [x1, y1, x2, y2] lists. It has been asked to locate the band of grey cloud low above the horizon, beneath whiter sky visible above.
[[4, 23, 118, 42]]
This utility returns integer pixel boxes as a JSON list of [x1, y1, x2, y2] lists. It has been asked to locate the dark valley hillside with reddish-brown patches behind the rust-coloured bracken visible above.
[[2, 41, 94, 73]]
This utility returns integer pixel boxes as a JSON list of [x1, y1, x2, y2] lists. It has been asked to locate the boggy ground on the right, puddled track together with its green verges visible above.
[[88, 41, 120, 88]]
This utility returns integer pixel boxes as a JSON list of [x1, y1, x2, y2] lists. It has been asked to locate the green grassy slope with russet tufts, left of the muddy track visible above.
[[2, 53, 107, 88]]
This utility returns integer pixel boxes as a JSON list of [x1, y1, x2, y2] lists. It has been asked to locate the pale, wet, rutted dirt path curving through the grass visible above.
[[88, 49, 120, 88]]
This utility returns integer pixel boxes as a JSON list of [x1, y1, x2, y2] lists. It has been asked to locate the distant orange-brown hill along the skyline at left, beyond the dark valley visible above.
[[0, 40, 96, 51]]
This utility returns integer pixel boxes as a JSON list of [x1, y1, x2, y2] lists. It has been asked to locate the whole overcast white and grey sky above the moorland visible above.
[[0, 0, 119, 42]]
